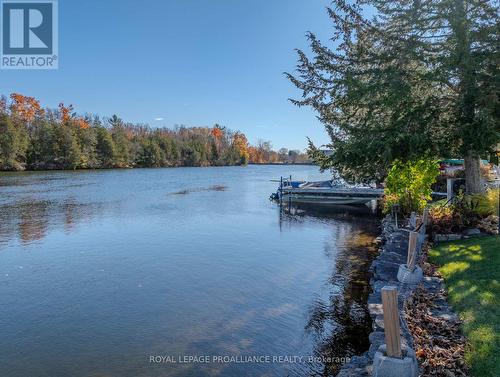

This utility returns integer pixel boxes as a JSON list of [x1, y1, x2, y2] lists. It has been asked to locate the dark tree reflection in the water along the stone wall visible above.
[[280, 205, 377, 376]]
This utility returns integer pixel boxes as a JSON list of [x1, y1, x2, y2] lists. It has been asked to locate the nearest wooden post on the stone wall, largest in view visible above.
[[381, 286, 401, 358]]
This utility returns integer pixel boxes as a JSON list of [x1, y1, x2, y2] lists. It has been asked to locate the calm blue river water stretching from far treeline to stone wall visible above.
[[0, 166, 377, 377]]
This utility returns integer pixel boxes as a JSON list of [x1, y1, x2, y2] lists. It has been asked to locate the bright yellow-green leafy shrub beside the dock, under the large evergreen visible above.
[[385, 159, 439, 215]]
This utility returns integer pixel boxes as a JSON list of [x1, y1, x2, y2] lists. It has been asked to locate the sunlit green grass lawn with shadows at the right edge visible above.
[[429, 237, 500, 377]]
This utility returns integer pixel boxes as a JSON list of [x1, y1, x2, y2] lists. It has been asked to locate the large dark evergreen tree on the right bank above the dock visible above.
[[288, 0, 500, 193]]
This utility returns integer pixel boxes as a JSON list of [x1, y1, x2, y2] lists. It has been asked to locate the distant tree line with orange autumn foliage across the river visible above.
[[0, 93, 305, 170]]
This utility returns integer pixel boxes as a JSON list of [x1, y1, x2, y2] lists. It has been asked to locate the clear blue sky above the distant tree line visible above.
[[0, 0, 332, 149]]
